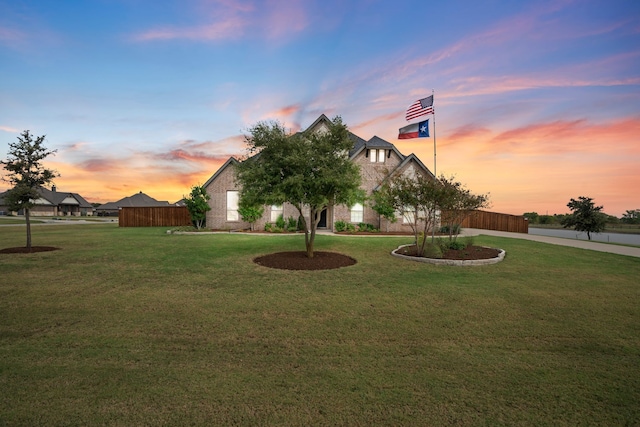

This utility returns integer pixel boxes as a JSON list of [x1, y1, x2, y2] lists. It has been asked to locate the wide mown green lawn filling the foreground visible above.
[[0, 224, 640, 426]]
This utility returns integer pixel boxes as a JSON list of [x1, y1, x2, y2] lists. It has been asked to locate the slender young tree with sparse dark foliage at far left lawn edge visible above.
[[0, 130, 59, 251]]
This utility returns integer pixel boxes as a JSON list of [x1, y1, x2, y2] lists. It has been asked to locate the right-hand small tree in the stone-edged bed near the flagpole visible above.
[[438, 175, 489, 242]]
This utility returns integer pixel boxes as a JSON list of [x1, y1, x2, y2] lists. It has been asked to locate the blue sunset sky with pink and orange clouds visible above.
[[0, 0, 640, 217]]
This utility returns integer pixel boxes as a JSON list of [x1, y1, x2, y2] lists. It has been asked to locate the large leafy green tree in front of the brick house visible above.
[[236, 116, 361, 258]]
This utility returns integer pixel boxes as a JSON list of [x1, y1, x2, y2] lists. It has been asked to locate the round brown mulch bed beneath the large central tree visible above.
[[253, 251, 357, 270]]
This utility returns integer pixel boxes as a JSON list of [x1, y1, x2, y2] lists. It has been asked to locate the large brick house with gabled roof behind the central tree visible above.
[[204, 114, 433, 232]]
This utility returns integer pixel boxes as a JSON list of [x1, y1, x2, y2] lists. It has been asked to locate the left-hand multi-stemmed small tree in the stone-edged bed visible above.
[[376, 174, 442, 254]]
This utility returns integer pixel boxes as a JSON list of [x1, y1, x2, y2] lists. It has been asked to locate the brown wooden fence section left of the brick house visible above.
[[118, 206, 191, 227]]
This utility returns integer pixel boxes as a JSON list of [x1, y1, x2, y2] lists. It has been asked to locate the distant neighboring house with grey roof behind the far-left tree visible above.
[[0, 186, 93, 216]]
